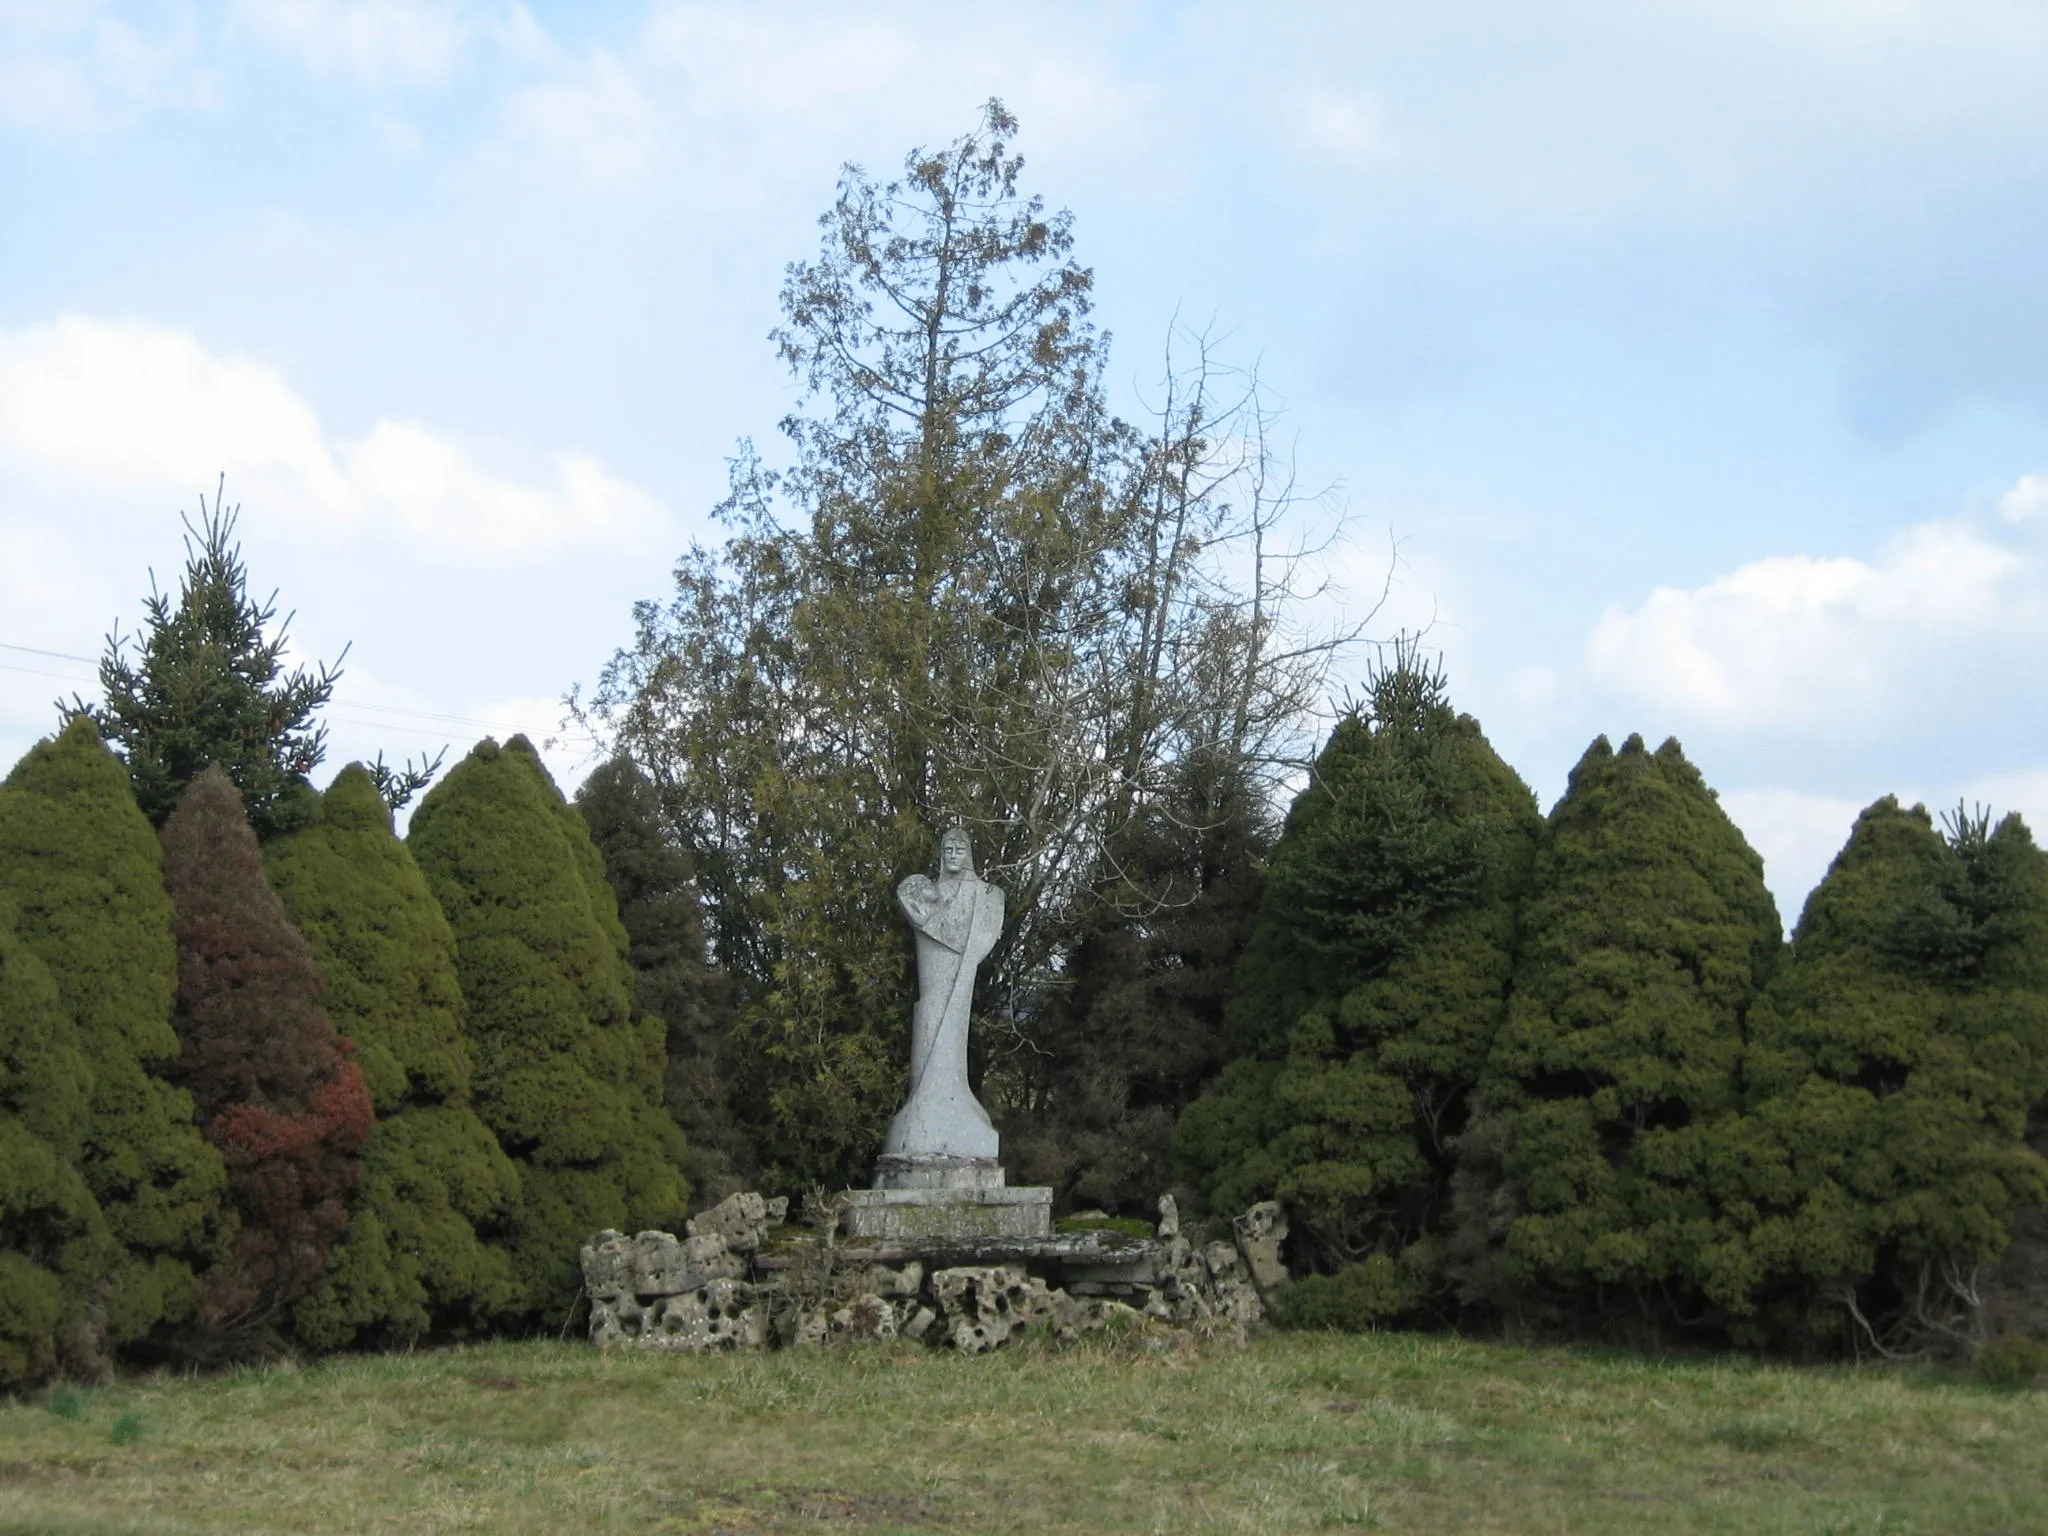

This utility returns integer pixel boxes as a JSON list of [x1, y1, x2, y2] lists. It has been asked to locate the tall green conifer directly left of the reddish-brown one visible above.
[[0, 721, 227, 1343]]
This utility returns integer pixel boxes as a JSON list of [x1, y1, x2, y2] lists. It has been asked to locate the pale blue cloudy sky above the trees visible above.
[[0, 0, 2048, 924]]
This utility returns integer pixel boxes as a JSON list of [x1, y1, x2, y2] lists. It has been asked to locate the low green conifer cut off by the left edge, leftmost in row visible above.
[[0, 893, 119, 1391]]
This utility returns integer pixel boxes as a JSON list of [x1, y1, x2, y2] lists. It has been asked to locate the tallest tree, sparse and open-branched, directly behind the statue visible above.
[[592, 102, 1351, 1186]]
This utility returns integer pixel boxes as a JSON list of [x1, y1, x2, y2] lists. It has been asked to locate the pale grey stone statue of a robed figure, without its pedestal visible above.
[[883, 827, 1004, 1182]]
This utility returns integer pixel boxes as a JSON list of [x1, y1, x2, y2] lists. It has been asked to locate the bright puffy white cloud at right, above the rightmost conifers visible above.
[[1587, 507, 2048, 729]]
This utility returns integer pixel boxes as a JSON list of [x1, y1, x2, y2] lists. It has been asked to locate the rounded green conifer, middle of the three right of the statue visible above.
[[1458, 735, 1782, 1327]]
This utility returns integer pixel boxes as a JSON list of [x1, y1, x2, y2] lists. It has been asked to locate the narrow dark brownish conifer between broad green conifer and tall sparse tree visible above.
[[575, 758, 756, 1204]]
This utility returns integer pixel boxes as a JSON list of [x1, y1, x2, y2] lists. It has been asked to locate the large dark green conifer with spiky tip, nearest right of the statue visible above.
[[1176, 647, 1540, 1321]]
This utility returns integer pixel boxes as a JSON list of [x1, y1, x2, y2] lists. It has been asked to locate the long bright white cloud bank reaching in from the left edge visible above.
[[0, 315, 662, 561]]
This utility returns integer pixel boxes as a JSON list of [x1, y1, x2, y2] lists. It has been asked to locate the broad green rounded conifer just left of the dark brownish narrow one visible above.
[[408, 737, 688, 1323]]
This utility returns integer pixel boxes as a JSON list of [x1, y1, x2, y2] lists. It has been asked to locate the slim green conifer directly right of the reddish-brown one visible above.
[[264, 764, 518, 1348]]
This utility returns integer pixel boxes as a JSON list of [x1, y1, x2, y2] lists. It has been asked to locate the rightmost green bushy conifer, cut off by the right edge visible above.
[[1704, 797, 2048, 1350]]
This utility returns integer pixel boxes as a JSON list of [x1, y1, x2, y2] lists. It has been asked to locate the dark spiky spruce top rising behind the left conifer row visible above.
[[78, 483, 342, 838]]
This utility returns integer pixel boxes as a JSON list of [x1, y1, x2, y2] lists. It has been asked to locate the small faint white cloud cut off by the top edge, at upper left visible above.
[[236, 0, 475, 88]]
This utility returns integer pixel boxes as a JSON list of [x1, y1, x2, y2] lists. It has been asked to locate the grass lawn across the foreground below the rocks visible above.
[[0, 1333, 2048, 1536]]
